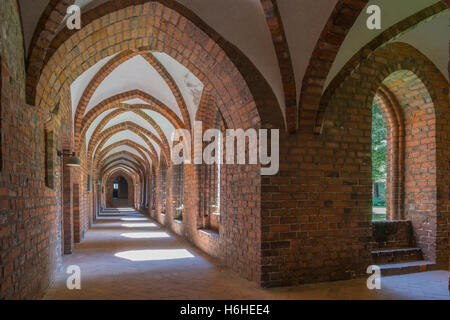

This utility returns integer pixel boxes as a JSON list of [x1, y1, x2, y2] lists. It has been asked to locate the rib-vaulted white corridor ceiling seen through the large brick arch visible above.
[[70, 51, 197, 176]]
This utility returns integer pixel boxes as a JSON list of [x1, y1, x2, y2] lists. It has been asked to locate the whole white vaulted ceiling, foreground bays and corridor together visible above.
[[18, 0, 449, 179]]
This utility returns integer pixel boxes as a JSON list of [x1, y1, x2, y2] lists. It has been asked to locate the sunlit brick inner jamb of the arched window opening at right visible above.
[[384, 70, 438, 261]]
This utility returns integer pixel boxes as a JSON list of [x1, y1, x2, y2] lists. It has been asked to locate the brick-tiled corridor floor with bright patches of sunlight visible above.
[[43, 211, 450, 300]]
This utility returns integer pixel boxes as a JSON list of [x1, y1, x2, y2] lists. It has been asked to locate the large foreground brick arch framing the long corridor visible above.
[[27, 0, 284, 128]]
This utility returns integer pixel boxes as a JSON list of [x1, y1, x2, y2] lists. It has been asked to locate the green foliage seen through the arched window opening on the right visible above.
[[372, 101, 387, 182]]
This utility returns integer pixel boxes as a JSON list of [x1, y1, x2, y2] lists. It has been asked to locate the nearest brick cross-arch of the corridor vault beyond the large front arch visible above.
[[75, 90, 184, 148]]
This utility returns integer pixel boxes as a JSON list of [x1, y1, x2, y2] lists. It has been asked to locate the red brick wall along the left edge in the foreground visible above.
[[0, 0, 61, 299]]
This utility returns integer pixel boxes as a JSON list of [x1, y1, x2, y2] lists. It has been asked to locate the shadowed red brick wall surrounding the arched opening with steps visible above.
[[262, 43, 450, 286]]
